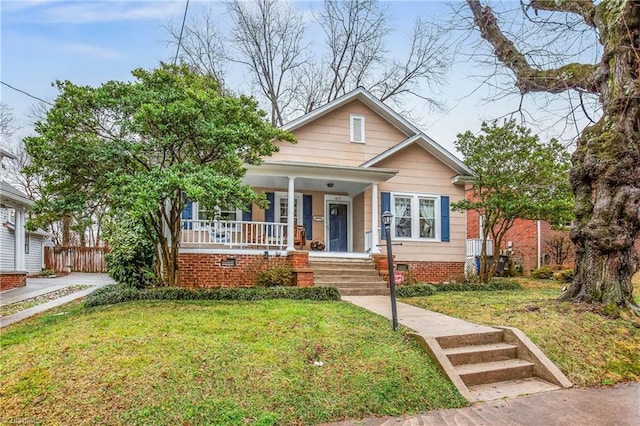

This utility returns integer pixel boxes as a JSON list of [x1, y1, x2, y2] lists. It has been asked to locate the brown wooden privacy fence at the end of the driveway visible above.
[[44, 246, 109, 272]]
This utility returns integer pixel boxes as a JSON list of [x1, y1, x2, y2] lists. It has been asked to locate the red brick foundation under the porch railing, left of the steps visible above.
[[178, 251, 313, 288]]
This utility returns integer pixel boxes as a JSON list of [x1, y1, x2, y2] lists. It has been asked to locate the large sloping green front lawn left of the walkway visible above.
[[0, 300, 467, 425]]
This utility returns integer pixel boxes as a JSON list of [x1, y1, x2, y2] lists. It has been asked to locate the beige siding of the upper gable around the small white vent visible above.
[[272, 100, 407, 166]]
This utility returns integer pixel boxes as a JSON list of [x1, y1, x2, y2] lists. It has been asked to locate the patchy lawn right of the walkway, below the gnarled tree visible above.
[[403, 276, 640, 386]]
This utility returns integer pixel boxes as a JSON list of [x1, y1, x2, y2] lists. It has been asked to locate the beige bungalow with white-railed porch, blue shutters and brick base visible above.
[[179, 88, 471, 287]]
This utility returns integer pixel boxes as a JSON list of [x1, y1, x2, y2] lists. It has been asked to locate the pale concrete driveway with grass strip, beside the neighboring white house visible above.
[[0, 272, 114, 328]]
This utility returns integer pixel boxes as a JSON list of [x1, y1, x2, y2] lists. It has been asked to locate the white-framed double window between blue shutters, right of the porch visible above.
[[391, 194, 439, 240]]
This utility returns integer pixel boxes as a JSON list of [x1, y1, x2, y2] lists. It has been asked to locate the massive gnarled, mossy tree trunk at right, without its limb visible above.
[[562, 2, 640, 312]]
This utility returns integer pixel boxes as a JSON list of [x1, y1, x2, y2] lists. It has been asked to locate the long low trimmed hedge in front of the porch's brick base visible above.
[[85, 284, 340, 307]]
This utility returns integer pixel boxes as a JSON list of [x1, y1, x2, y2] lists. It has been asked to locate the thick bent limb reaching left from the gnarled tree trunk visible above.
[[467, 0, 600, 94]]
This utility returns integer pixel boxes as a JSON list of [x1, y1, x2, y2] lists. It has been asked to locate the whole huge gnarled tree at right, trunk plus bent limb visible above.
[[467, 0, 640, 314]]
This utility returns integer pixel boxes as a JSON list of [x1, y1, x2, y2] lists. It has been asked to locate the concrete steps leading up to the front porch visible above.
[[309, 257, 389, 296]]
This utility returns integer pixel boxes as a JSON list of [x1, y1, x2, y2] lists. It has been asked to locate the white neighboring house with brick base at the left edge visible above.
[[0, 181, 49, 290]]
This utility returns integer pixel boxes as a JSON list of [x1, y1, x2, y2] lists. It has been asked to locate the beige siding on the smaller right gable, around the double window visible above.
[[377, 145, 466, 262]]
